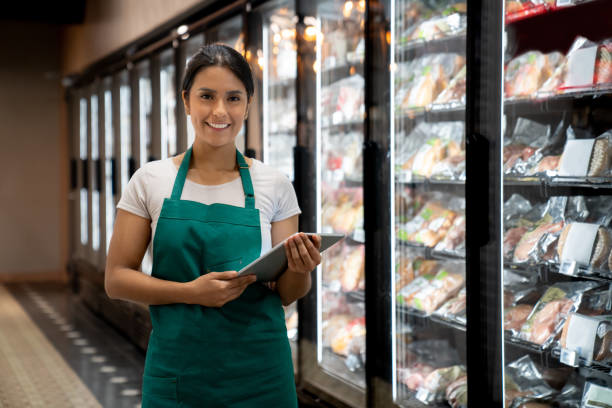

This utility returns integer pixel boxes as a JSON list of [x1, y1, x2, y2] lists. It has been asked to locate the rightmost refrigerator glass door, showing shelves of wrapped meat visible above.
[[501, 1, 612, 407]]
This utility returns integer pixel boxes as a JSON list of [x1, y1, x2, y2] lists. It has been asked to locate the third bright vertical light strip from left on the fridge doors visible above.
[[104, 89, 115, 251]]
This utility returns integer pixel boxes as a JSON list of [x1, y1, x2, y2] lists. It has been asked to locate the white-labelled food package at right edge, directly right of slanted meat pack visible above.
[[559, 313, 612, 362]]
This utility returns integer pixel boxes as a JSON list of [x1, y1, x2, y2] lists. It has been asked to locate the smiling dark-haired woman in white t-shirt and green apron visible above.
[[105, 44, 321, 408]]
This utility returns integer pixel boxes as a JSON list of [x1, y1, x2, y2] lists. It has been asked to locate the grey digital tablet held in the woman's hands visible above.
[[238, 233, 344, 282]]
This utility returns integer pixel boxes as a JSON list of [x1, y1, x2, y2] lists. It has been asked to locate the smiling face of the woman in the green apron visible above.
[[183, 66, 249, 147]]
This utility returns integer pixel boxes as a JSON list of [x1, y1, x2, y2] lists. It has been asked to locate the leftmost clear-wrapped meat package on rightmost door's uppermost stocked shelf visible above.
[[504, 51, 564, 99]]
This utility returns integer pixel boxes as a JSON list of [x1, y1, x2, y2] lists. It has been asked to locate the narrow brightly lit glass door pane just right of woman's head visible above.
[[262, 8, 297, 180]]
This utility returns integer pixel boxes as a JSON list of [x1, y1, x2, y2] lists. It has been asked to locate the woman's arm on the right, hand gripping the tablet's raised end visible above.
[[272, 215, 321, 306]]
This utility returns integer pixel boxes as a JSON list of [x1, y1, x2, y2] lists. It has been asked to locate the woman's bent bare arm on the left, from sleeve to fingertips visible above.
[[104, 209, 254, 307]]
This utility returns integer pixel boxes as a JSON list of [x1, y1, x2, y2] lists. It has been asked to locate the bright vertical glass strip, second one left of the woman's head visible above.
[[160, 50, 177, 159]]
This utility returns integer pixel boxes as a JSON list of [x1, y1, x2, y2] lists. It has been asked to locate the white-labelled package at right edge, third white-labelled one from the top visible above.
[[557, 223, 612, 269]]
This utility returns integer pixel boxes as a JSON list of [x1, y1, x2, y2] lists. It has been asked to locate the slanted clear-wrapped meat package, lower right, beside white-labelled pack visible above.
[[519, 282, 598, 348]]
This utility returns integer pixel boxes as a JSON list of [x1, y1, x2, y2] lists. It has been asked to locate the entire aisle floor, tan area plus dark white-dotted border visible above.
[[0, 283, 144, 408]]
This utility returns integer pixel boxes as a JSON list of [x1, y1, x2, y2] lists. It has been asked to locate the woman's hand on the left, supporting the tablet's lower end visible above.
[[187, 271, 257, 307]]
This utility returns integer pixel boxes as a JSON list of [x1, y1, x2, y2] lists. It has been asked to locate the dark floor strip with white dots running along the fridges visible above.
[[5, 283, 144, 408]]
